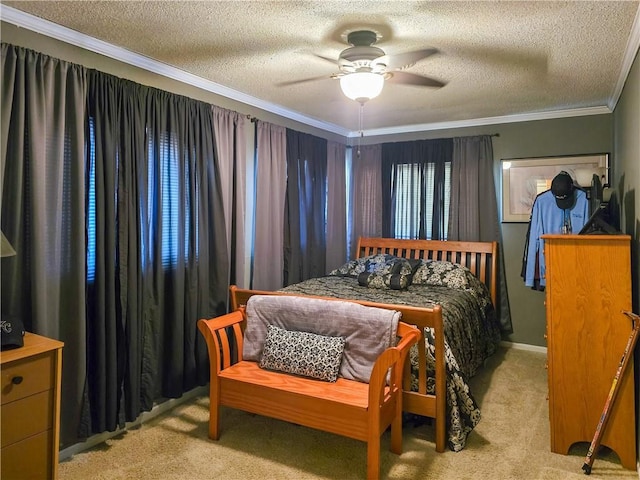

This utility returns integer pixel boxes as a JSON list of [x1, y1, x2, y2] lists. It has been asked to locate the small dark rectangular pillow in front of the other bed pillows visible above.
[[358, 255, 420, 290]]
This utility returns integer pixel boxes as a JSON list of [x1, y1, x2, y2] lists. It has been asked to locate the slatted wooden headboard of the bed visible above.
[[356, 237, 498, 305]]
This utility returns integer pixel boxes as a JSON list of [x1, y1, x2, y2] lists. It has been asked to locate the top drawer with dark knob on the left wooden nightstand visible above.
[[0, 352, 55, 405]]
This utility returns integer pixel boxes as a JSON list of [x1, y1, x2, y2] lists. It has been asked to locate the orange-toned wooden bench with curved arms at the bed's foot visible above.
[[198, 300, 421, 479]]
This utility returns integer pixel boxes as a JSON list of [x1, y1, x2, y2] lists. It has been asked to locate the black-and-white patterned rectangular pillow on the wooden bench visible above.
[[260, 325, 345, 382]]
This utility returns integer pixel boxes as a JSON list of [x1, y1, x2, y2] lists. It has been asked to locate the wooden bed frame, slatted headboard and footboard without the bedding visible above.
[[230, 237, 498, 452]]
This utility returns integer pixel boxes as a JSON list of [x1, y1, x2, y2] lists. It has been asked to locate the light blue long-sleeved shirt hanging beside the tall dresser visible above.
[[524, 189, 589, 287]]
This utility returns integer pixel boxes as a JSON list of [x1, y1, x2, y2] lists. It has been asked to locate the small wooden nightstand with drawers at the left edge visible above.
[[0, 333, 63, 480]]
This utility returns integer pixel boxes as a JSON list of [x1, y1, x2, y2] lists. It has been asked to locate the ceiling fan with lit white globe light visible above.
[[279, 30, 445, 103]]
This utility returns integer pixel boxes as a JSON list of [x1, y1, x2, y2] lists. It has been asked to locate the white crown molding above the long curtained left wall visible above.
[[0, 5, 349, 137]]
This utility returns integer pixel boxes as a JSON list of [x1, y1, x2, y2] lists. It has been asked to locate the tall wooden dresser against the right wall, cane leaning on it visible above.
[[542, 235, 637, 469]]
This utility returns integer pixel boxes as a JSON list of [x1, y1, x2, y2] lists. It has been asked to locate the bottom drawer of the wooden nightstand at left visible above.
[[0, 430, 53, 480]]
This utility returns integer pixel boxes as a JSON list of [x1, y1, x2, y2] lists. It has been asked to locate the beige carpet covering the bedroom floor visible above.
[[59, 349, 639, 480]]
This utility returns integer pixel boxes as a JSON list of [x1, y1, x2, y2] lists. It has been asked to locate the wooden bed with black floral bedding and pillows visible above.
[[231, 237, 500, 452]]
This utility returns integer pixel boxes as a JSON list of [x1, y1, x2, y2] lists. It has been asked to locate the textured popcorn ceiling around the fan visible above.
[[2, 1, 640, 137]]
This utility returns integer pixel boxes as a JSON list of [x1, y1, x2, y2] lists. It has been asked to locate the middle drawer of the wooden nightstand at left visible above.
[[1, 390, 53, 448]]
